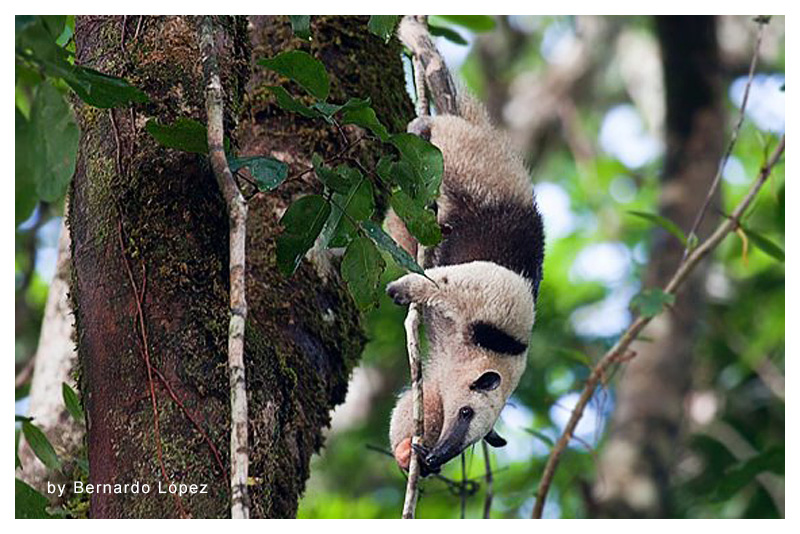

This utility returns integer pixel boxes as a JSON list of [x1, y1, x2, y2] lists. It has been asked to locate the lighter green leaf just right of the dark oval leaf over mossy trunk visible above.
[[322, 165, 375, 248]]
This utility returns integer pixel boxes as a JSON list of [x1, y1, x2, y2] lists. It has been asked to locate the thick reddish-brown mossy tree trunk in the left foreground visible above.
[[69, 17, 412, 517]]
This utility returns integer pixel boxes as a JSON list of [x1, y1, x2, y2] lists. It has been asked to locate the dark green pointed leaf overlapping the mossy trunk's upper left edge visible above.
[[64, 66, 149, 108]]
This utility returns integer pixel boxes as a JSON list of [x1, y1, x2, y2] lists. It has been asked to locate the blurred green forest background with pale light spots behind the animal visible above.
[[15, 16, 785, 518]]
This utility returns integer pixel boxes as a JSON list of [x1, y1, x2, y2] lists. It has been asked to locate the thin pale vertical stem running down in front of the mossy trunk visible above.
[[200, 16, 250, 519]]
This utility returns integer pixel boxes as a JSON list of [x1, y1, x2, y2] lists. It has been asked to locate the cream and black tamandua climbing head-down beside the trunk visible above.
[[387, 98, 544, 475]]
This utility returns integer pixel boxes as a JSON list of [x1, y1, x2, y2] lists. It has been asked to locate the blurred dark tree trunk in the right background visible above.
[[595, 17, 725, 517]]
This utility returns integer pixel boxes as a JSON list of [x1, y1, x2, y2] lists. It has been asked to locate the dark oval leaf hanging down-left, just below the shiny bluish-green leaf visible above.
[[276, 195, 331, 276]]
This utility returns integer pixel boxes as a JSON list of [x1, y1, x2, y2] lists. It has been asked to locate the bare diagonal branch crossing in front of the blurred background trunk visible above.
[[532, 134, 786, 519]]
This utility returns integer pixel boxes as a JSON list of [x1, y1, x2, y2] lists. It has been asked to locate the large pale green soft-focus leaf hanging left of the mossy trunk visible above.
[[29, 83, 80, 202]]
